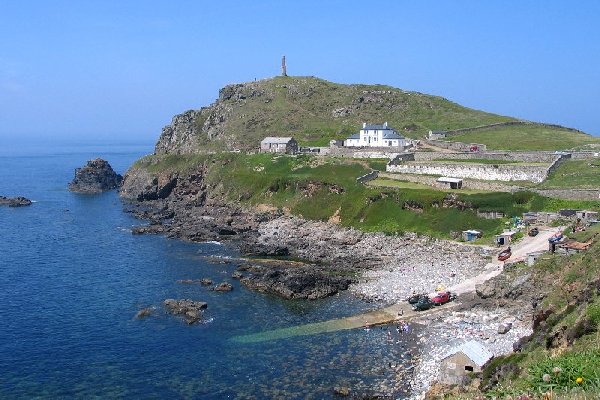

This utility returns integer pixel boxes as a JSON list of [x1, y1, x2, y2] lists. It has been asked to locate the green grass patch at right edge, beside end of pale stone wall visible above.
[[539, 159, 600, 190]]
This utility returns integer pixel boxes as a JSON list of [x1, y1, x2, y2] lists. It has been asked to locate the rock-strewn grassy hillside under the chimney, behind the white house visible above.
[[195, 77, 514, 148]]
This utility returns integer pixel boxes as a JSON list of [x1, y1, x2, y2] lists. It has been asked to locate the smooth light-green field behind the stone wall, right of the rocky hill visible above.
[[448, 125, 600, 150]]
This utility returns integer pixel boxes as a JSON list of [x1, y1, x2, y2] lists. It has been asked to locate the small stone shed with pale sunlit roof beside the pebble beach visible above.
[[438, 340, 494, 385]]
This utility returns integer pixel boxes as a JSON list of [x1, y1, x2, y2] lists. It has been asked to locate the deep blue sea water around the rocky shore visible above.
[[0, 145, 418, 399]]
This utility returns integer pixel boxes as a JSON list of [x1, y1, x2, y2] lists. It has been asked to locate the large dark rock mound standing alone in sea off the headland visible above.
[[69, 158, 123, 193]]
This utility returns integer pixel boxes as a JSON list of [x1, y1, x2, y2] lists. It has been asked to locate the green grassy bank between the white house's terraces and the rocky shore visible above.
[[136, 153, 595, 241]]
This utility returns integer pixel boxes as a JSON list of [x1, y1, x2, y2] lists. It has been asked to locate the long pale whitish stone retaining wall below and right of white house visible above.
[[386, 162, 548, 183]]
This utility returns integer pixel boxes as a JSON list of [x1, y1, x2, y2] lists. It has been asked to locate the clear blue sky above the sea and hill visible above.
[[0, 0, 600, 142]]
